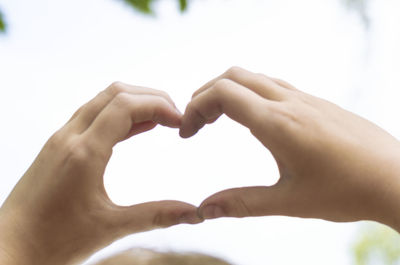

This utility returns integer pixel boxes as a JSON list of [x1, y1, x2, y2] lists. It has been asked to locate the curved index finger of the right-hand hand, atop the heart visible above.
[[180, 79, 269, 138]]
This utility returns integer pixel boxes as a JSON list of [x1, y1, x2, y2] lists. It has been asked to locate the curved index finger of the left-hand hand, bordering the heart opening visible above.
[[85, 93, 181, 148]]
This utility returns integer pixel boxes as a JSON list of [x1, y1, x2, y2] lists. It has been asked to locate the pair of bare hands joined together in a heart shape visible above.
[[0, 67, 400, 265]]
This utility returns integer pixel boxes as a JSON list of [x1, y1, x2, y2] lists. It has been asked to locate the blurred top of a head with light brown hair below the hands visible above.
[[95, 249, 232, 265]]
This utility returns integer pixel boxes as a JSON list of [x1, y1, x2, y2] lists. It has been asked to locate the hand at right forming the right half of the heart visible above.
[[180, 67, 400, 231]]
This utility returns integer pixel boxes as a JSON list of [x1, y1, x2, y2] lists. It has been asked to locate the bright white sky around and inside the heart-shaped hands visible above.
[[0, 0, 400, 265]]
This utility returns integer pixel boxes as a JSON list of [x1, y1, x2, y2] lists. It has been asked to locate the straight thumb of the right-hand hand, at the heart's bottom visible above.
[[198, 185, 290, 219]]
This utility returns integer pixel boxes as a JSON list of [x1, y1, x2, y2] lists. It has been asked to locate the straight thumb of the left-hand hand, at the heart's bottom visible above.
[[112, 201, 203, 235]]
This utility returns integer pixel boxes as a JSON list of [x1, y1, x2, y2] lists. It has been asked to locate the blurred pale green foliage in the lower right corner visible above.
[[353, 223, 400, 265]]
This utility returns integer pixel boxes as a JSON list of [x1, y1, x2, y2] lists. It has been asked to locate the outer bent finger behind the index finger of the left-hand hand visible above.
[[68, 82, 176, 133]]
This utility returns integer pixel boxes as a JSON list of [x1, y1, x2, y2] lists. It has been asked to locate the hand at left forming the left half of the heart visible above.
[[0, 83, 201, 265]]
